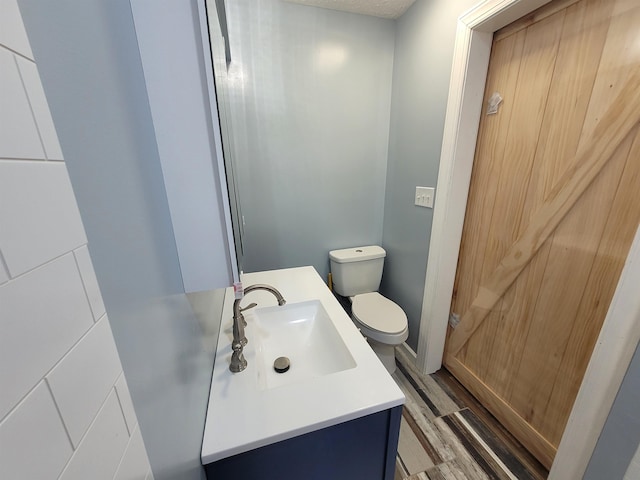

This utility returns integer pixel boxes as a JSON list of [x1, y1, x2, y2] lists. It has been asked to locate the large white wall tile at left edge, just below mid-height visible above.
[[0, 253, 94, 418]]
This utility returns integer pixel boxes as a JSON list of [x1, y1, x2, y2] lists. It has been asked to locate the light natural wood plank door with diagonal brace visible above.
[[444, 0, 640, 467]]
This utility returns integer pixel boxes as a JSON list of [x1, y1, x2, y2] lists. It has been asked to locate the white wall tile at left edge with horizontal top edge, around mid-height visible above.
[[0, 160, 87, 278]]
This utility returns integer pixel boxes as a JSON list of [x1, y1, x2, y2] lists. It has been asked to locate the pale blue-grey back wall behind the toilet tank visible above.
[[227, 0, 395, 278]]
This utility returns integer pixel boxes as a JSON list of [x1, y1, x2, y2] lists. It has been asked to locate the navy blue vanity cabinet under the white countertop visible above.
[[205, 400, 402, 480]]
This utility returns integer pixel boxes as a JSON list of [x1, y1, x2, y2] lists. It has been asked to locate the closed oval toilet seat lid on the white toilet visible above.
[[351, 292, 408, 336]]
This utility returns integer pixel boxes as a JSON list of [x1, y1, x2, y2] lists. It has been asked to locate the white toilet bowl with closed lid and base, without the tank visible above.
[[350, 292, 409, 373]]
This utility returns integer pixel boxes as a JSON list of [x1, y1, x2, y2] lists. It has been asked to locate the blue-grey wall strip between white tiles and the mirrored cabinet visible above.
[[20, 0, 225, 480]]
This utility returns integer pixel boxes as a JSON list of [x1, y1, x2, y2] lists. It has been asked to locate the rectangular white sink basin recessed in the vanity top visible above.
[[252, 300, 356, 390]]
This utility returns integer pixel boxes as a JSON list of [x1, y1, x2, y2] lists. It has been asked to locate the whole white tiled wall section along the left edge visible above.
[[0, 6, 153, 480]]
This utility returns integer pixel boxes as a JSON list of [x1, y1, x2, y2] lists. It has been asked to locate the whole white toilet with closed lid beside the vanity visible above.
[[329, 245, 409, 373]]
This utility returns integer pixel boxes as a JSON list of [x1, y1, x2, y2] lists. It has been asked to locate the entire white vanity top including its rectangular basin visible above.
[[202, 267, 404, 465]]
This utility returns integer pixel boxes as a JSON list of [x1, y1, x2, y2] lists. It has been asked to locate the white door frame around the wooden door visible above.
[[416, 0, 640, 479]]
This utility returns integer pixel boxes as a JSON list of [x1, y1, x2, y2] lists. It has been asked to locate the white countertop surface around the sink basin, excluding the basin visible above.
[[202, 267, 405, 465]]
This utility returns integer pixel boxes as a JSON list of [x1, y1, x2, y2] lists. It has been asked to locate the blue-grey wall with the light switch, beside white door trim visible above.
[[381, 0, 478, 350]]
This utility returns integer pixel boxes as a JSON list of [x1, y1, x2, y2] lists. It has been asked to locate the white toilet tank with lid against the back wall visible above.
[[329, 245, 387, 297]]
